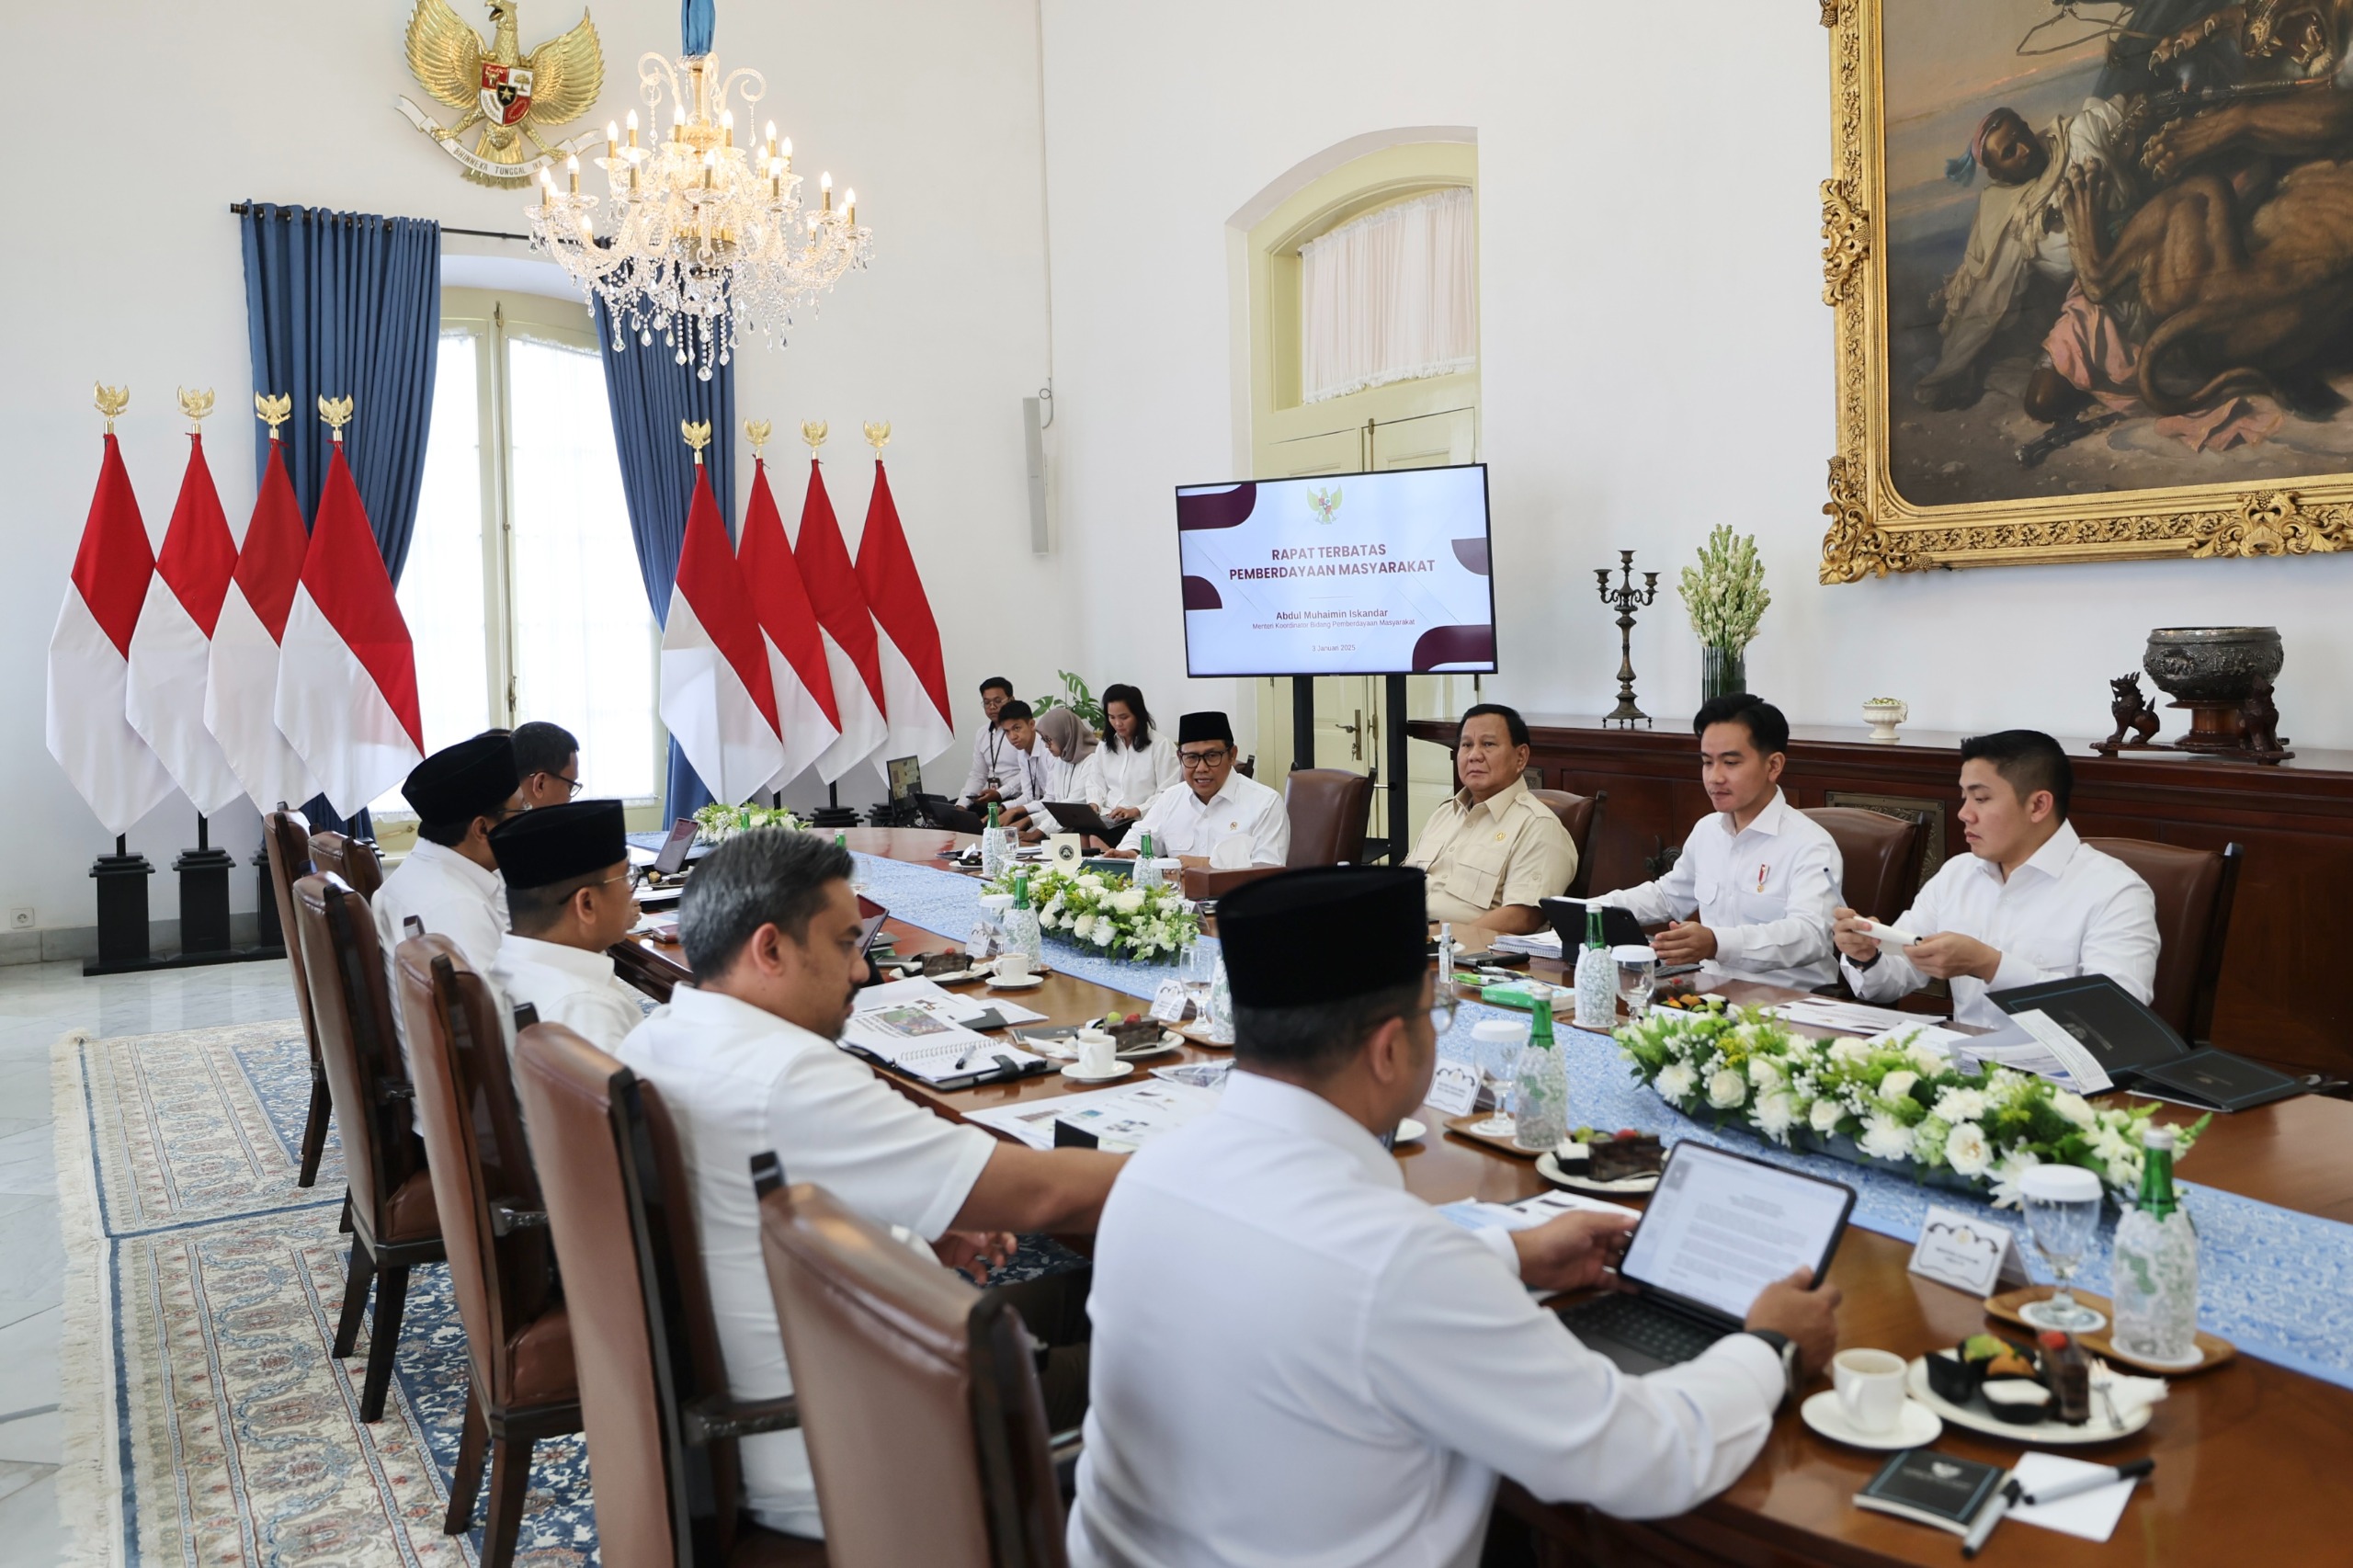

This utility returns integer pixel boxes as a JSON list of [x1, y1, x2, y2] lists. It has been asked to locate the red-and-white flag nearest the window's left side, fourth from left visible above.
[[276, 443, 426, 817]]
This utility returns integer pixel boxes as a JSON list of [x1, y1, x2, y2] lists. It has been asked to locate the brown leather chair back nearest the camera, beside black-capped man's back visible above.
[[757, 1168, 1077, 1568]]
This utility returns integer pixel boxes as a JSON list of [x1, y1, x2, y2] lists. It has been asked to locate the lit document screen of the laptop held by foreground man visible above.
[[1623, 1144, 1847, 1318]]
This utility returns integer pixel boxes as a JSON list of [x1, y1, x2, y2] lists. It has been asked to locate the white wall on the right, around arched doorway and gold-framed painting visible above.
[[1045, 0, 2353, 746]]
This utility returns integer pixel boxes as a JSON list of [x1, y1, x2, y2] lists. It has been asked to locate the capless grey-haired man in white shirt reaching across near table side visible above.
[[617, 829, 1122, 1535]]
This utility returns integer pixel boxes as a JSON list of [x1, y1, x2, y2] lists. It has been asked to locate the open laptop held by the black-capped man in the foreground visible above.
[[1560, 1142, 1854, 1372]]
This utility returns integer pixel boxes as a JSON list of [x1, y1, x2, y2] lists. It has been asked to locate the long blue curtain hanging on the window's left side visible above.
[[238, 202, 440, 835]]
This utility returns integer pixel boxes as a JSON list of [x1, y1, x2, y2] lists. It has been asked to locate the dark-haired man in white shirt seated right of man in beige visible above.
[[1593, 692, 1845, 989]]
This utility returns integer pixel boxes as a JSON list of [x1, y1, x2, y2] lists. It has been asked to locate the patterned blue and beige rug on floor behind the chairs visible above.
[[54, 1022, 597, 1568]]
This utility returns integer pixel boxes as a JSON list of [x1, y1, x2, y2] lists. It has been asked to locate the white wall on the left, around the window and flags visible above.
[[0, 0, 1056, 927]]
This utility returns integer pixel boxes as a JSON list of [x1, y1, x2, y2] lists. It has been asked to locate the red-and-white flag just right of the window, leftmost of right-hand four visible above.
[[661, 460, 783, 805]]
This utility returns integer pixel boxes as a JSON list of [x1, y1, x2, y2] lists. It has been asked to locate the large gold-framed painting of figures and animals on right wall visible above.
[[1819, 0, 2353, 584]]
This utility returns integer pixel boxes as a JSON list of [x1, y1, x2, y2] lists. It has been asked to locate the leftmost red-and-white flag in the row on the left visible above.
[[50, 431, 172, 835]]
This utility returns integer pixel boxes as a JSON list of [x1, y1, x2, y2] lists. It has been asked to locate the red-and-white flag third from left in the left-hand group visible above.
[[208, 436, 318, 812]]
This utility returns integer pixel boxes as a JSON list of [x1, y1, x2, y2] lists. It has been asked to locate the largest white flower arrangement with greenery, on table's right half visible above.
[[1617, 993, 2205, 1208]]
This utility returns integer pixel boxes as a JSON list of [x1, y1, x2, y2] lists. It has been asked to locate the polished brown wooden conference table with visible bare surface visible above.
[[614, 829, 2353, 1568]]
